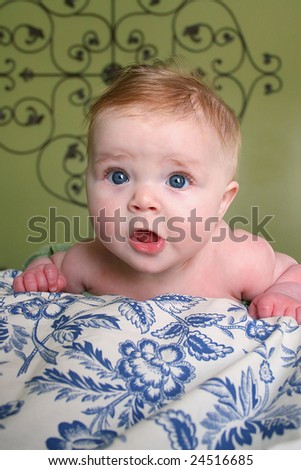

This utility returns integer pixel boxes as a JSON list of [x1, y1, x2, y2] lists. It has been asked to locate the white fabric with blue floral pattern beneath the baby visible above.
[[0, 270, 301, 450]]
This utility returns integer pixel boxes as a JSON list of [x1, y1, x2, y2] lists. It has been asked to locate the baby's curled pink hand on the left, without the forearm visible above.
[[13, 262, 67, 292]]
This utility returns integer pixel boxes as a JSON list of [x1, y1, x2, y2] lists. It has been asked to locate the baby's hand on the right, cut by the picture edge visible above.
[[249, 292, 301, 324]]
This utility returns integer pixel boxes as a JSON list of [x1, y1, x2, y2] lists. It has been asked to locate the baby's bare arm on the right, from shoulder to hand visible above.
[[224, 230, 301, 324]]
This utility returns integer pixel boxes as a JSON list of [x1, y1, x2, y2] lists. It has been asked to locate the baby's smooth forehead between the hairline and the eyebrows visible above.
[[91, 106, 224, 162]]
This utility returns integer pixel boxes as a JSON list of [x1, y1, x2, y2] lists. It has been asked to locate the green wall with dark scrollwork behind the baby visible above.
[[0, 0, 301, 268]]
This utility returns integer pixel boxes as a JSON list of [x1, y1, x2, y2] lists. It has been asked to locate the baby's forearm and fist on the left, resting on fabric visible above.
[[13, 251, 67, 292]]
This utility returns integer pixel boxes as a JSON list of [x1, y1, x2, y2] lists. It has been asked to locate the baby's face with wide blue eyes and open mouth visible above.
[[87, 108, 237, 273]]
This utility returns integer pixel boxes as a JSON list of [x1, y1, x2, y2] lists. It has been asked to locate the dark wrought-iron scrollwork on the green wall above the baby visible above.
[[0, 0, 282, 206]]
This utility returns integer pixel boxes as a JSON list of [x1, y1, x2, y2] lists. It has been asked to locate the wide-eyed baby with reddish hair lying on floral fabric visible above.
[[14, 62, 301, 323]]
